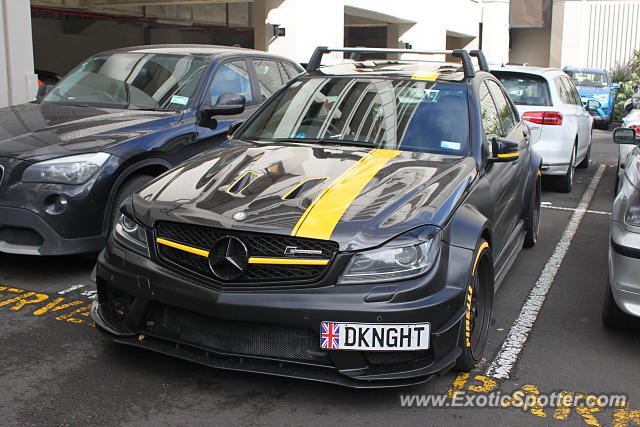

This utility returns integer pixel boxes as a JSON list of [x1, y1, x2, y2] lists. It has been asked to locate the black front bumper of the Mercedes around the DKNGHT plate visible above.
[[91, 241, 472, 388]]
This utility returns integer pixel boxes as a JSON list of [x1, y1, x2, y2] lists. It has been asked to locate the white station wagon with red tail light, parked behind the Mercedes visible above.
[[492, 66, 598, 193]]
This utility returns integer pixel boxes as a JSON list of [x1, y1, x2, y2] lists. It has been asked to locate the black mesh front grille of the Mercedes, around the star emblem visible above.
[[156, 222, 338, 286]]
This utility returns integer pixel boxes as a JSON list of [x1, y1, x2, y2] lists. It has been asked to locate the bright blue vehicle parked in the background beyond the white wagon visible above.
[[564, 68, 620, 129]]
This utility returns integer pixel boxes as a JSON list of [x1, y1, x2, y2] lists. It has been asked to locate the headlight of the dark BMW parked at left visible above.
[[22, 153, 110, 185]]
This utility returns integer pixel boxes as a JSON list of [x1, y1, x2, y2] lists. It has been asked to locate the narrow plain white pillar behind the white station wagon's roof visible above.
[[482, 0, 509, 64]]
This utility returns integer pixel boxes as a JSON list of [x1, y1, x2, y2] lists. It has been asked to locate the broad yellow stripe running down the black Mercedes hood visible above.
[[291, 148, 400, 240]]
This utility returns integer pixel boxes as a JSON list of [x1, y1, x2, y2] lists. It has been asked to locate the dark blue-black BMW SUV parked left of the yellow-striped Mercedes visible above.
[[0, 45, 302, 255]]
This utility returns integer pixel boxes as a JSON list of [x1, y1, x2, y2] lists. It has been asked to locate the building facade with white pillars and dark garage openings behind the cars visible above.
[[0, 0, 640, 106]]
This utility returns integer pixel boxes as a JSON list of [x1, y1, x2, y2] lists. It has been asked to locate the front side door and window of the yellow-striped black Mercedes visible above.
[[478, 79, 524, 252]]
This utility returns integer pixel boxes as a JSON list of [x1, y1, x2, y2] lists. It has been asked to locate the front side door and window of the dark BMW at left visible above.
[[197, 58, 262, 146]]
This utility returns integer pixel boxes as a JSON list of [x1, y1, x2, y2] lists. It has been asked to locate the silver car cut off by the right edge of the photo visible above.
[[602, 128, 640, 328]]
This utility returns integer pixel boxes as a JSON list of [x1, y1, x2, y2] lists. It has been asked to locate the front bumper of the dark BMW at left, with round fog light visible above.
[[0, 156, 120, 255]]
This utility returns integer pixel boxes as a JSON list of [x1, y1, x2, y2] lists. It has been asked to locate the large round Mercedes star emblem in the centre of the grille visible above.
[[209, 236, 249, 281]]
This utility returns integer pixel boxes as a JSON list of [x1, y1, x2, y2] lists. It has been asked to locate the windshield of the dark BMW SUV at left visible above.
[[42, 53, 208, 110]]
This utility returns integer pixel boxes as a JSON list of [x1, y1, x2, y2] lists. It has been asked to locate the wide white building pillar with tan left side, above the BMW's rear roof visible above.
[[253, 0, 344, 64]]
